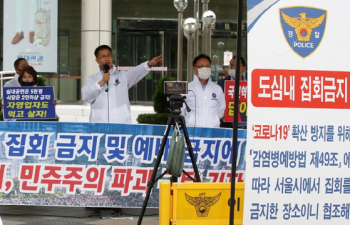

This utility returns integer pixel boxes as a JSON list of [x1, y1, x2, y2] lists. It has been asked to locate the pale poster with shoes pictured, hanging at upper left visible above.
[[3, 0, 58, 73]]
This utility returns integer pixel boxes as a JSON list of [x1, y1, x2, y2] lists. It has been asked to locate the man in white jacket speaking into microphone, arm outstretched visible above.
[[81, 45, 163, 124]]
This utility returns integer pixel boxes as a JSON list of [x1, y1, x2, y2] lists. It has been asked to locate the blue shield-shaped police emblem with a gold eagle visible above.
[[279, 6, 327, 58]]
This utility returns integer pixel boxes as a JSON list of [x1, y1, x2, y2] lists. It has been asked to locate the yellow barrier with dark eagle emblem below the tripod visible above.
[[159, 182, 244, 225]]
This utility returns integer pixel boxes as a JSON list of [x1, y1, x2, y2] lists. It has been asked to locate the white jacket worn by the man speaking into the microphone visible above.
[[81, 62, 151, 124]]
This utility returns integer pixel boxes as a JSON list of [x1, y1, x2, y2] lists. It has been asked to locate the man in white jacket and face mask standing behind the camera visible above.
[[181, 54, 226, 127]]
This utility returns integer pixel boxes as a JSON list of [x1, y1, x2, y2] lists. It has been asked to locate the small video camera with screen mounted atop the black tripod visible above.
[[164, 81, 191, 115]]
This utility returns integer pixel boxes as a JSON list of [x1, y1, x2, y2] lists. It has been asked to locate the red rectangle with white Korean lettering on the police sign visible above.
[[251, 69, 350, 109]]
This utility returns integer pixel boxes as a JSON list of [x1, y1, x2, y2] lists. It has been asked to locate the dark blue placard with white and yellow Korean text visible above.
[[3, 87, 56, 120]]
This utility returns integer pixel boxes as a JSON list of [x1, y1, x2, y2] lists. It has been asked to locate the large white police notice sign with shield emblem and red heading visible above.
[[243, 0, 350, 225]]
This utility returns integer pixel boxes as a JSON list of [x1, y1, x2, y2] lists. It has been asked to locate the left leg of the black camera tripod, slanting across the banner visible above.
[[137, 117, 174, 225]]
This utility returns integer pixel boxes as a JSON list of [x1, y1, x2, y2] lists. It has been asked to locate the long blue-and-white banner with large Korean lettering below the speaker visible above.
[[0, 122, 246, 207]]
